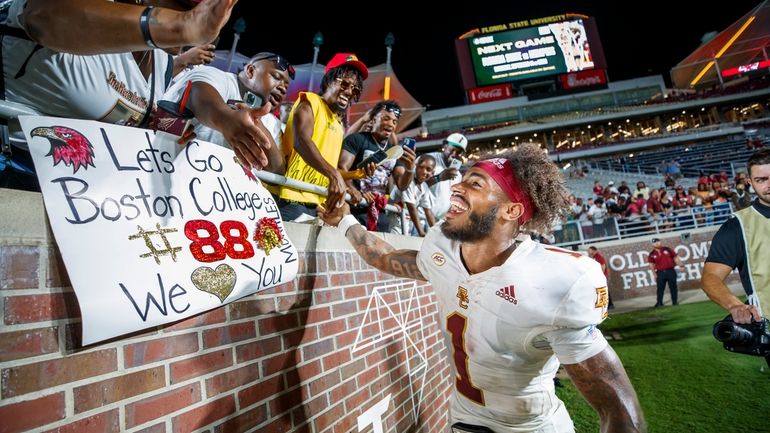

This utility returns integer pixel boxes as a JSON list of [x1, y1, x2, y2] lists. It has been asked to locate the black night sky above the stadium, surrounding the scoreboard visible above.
[[218, 0, 760, 109]]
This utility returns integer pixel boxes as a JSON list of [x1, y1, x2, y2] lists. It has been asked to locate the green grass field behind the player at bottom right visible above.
[[557, 302, 770, 433]]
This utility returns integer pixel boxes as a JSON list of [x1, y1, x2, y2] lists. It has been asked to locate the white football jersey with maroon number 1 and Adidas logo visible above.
[[417, 224, 608, 433]]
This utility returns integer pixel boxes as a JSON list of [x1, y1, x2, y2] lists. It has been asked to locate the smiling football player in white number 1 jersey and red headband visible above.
[[319, 145, 645, 433]]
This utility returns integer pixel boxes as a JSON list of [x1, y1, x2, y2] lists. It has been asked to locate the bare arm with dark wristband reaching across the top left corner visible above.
[[23, 0, 238, 55]]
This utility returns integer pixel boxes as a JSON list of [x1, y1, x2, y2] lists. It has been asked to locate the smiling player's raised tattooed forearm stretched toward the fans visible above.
[[347, 225, 425, 281]]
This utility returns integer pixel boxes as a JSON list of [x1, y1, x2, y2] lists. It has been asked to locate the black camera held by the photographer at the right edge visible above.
[[713, 315, 770, 357]]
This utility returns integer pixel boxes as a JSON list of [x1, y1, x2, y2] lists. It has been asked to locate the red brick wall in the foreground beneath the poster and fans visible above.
[[0, 190, 450, 433]]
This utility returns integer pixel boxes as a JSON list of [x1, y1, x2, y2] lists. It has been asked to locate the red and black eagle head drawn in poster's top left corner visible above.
[[31, 126, 96, 173]]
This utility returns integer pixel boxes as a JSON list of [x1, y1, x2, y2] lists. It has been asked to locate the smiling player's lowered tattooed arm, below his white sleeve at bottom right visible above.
[[564, 346, 647, 433]]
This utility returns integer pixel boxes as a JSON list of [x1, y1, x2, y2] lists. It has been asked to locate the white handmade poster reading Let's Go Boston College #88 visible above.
[[20, 116, 298, 345]]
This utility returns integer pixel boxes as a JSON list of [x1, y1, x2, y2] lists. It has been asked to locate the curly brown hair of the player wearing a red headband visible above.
[[488, 143, 569, 234]]
